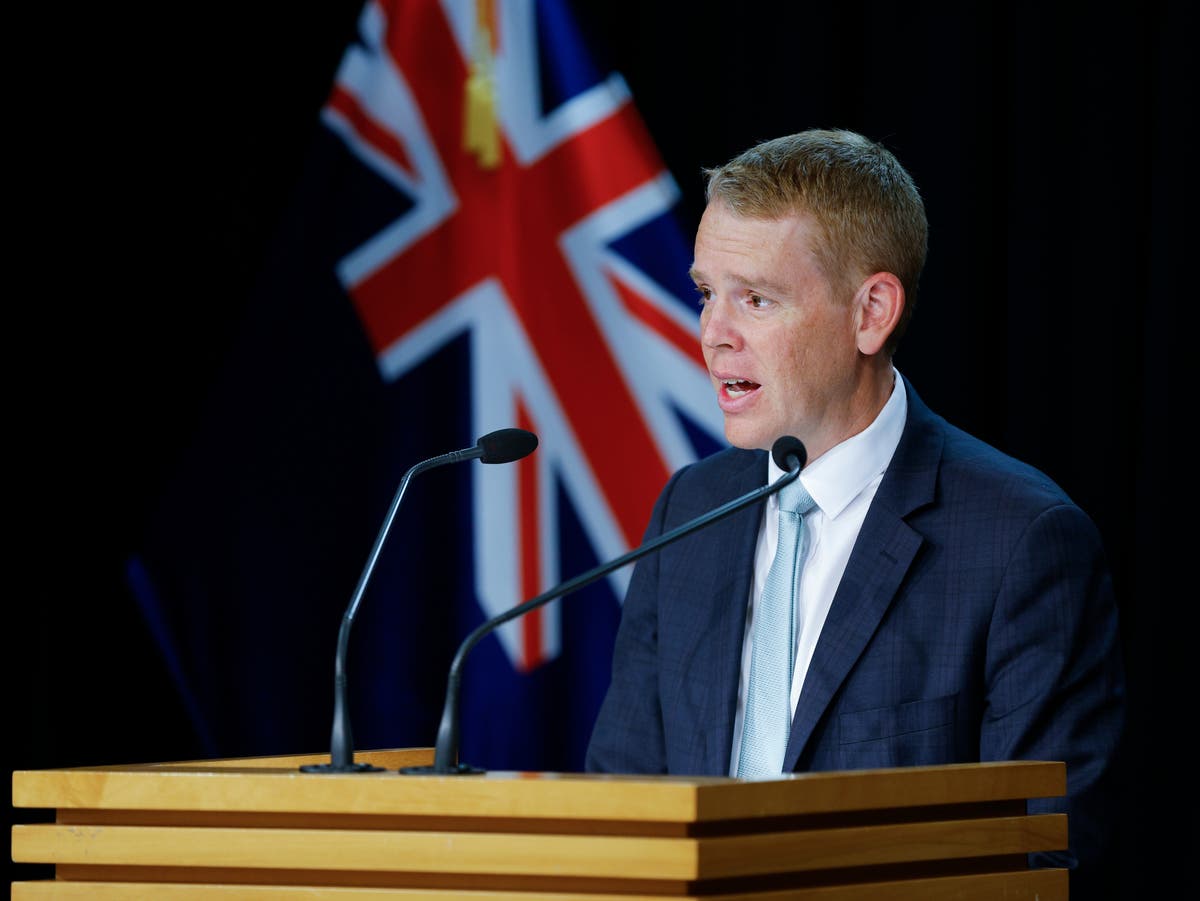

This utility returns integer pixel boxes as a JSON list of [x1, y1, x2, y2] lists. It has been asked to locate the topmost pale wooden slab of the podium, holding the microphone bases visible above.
[[12, 749, 1067, 823]]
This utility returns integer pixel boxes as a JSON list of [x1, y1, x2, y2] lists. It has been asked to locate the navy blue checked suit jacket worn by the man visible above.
[[587, 382, 1124, 883]]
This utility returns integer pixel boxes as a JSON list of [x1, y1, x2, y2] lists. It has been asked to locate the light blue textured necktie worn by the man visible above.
[[738, 479, 816, 779]]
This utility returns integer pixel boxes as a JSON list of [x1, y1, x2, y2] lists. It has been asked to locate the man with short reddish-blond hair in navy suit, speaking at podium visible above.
[[587, 131, 1124, 897]]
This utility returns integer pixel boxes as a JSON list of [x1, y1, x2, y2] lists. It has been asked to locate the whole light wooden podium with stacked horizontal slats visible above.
[[12, 749, 1067, 901]]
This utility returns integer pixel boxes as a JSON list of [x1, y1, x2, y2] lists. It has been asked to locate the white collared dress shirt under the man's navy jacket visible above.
[[730, 370, 908, 776]]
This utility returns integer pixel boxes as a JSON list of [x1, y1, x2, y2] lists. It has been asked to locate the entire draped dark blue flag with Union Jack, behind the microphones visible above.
[[131, 0, 721, 770]]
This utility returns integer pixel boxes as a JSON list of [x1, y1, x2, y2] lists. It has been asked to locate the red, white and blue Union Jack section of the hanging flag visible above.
[[322, 0, 721, 763]]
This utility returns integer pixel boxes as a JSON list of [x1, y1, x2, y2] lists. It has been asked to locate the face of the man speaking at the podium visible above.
[[691, 202, 860, 458]]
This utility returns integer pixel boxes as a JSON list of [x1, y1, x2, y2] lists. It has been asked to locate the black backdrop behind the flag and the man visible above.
[[5, 0, 1196, 899]]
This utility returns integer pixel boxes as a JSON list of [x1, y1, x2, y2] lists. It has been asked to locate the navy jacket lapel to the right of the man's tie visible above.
[[784, 382, 942, 771]]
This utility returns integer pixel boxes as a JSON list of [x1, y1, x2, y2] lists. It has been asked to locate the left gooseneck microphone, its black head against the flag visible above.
[[300, 428, 538, 773]]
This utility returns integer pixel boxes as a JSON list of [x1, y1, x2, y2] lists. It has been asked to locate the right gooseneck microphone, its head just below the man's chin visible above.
[[400, 436, 808, 775]]
